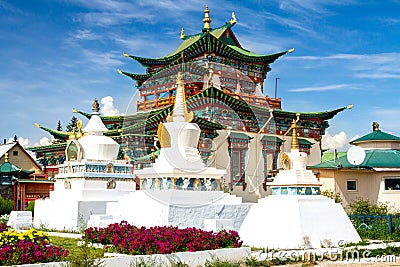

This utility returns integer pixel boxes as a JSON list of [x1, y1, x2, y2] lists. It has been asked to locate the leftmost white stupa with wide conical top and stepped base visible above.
[[34, 99, 136, 230]]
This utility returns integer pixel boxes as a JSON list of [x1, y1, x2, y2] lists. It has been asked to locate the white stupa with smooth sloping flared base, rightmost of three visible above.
[[239, 121, 361, 249]]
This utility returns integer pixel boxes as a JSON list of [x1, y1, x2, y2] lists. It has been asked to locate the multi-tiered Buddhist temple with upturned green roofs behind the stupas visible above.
[[30, 7, 351, 201]]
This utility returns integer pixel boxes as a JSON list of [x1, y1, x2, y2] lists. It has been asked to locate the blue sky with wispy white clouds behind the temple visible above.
[[0, 0, 400, 151]]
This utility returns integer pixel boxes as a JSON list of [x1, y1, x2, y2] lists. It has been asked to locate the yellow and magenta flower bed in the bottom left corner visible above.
[[0, 228, 68, 265]]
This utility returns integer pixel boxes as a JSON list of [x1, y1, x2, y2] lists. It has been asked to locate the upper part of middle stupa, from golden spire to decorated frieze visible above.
[[135, 73, 226, 191]]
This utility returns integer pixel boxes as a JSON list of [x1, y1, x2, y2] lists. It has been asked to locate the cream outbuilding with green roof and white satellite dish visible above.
[[309, 122, 400, 208]]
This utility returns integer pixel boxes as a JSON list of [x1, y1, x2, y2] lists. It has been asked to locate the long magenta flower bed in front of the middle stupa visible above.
[[82, 221, 242, 255]]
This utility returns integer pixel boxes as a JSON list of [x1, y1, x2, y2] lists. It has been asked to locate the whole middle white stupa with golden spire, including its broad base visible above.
[[107, 73, 251, 230]]
